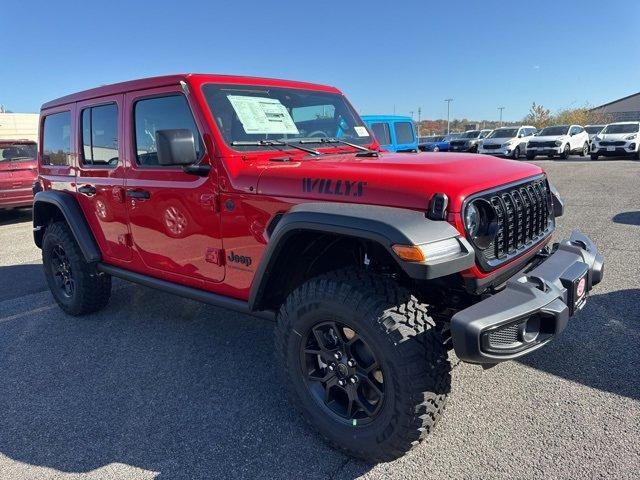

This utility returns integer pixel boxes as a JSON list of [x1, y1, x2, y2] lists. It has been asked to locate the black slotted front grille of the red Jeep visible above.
[[473, 178, 554, 270]]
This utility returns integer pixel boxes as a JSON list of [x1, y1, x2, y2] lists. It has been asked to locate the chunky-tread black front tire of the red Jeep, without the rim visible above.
[[275, 268, 451, 462]]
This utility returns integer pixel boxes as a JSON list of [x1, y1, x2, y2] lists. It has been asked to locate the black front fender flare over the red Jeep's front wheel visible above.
[[249, 202, 475, 310]]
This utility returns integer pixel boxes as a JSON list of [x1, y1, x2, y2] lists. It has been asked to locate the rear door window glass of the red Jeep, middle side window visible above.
[[82, 103, 118, 167]]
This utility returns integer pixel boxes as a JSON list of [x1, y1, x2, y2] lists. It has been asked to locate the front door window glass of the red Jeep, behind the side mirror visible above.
[[133, 94, 204, 166]]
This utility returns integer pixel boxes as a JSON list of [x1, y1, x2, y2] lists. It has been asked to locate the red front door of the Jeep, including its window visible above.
[[125, 85, 224, 286]]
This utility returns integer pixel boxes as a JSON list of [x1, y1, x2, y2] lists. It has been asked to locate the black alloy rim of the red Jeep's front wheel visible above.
[[300, 321, 385, 426]]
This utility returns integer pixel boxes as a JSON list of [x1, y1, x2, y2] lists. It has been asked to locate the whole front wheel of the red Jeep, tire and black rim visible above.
[[275, 269, 451, 462]]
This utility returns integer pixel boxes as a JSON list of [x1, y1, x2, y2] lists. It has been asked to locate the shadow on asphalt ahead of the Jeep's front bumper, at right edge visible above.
[[519, 289, 640, 400]]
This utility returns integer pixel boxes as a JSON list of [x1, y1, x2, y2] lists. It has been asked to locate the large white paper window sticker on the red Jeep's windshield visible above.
[[227, 95, 300, 135]]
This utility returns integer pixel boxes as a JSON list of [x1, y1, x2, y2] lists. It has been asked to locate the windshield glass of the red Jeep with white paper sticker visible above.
[[202, 84, 373, 150]]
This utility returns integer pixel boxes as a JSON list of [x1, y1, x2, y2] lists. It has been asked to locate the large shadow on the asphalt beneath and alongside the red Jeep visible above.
[[0, 284, 371, 479]]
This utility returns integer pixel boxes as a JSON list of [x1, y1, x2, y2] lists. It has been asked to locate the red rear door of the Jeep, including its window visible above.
[[76, 95, 131, 261]]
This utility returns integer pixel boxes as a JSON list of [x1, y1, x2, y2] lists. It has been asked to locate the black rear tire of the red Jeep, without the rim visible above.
[[42, 222, 111, 316]]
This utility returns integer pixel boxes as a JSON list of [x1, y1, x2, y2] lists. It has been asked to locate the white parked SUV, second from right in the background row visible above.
[[527, 125, 589, 160]]
